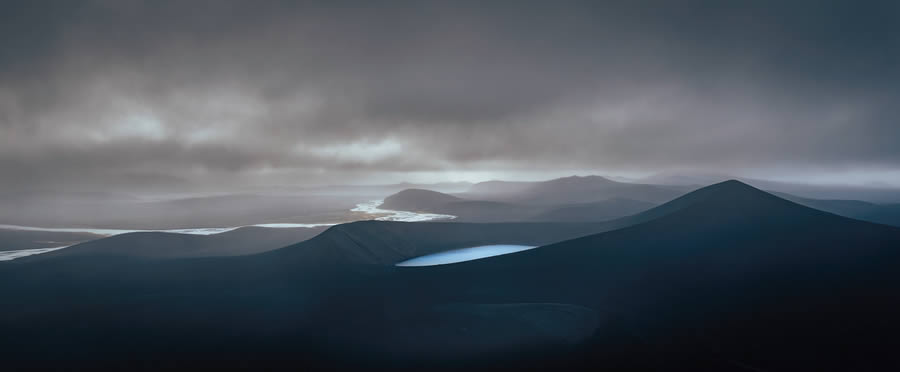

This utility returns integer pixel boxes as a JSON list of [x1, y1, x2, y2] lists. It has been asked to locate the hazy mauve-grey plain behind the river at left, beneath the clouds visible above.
[[0, 194, 362, 230]]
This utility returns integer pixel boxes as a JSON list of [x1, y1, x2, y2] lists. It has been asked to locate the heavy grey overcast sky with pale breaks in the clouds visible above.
[[0, 0, 900, 191]]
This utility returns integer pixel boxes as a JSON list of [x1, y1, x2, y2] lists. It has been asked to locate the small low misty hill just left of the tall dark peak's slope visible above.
[[531, 198, 656, 222]]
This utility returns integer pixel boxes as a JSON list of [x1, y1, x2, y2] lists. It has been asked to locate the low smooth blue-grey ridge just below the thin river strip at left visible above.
[[19, 226, 326, 262]]
